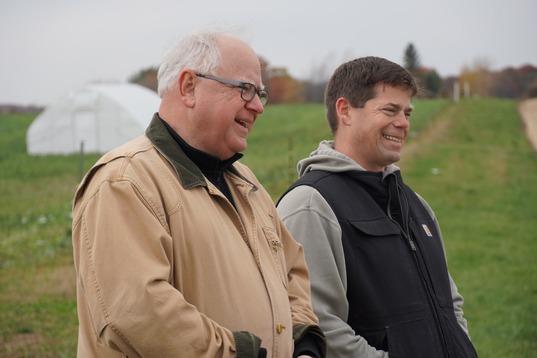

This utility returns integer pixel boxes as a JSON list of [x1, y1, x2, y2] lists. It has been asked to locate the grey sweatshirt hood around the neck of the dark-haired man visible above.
[[297, 140, 399, 178]]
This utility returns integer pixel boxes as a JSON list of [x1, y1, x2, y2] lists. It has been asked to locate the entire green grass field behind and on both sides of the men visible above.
[[0, 99, 537, 358]]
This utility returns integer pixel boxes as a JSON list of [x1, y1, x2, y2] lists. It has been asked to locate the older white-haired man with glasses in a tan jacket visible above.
[[73, 31, 325, 357]]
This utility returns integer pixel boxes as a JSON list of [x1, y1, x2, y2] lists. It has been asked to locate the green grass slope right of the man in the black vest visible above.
[[398, 99, 537, 357]]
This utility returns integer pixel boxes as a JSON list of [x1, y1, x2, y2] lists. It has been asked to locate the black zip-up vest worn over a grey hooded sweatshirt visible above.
[[278, 171, 477, 358]]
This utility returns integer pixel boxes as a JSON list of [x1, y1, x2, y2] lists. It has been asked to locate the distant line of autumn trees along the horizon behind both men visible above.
[[129, 43, 537, 104]]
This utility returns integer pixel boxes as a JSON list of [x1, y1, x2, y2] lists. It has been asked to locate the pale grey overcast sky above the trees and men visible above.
[[0, 0, 537, 105]]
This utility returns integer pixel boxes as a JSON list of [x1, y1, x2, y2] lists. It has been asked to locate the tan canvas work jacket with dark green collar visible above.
[[73, 116, 318, 357]]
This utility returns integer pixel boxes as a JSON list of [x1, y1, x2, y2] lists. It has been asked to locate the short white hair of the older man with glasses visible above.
[[157, 29, 247, 98]]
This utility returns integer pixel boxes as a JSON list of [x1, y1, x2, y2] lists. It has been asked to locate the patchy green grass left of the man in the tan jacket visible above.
[[0, 115, 97, 357]]
